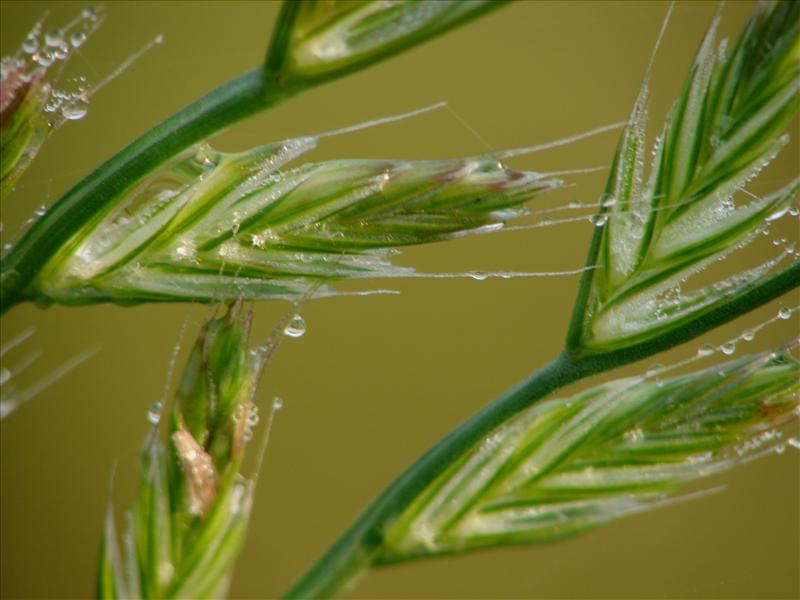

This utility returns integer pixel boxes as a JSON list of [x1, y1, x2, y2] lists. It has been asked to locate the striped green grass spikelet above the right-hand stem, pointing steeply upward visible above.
[[570, 2, 800, 352]]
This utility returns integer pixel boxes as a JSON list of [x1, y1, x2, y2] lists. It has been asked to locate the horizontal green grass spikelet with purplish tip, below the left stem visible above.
[[31, 137, 557, 304]]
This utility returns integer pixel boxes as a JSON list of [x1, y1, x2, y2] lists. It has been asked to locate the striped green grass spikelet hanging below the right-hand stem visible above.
[[376, 352, 800, 563]]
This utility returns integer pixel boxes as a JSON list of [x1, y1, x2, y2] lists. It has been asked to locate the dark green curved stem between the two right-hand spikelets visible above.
[[284, 263, 800, 598]]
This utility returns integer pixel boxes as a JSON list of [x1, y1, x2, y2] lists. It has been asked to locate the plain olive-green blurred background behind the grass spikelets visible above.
[[0, 2, 800, 598]]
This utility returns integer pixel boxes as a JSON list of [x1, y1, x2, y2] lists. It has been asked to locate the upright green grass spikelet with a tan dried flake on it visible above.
[[97, 301, 268, 598]]
